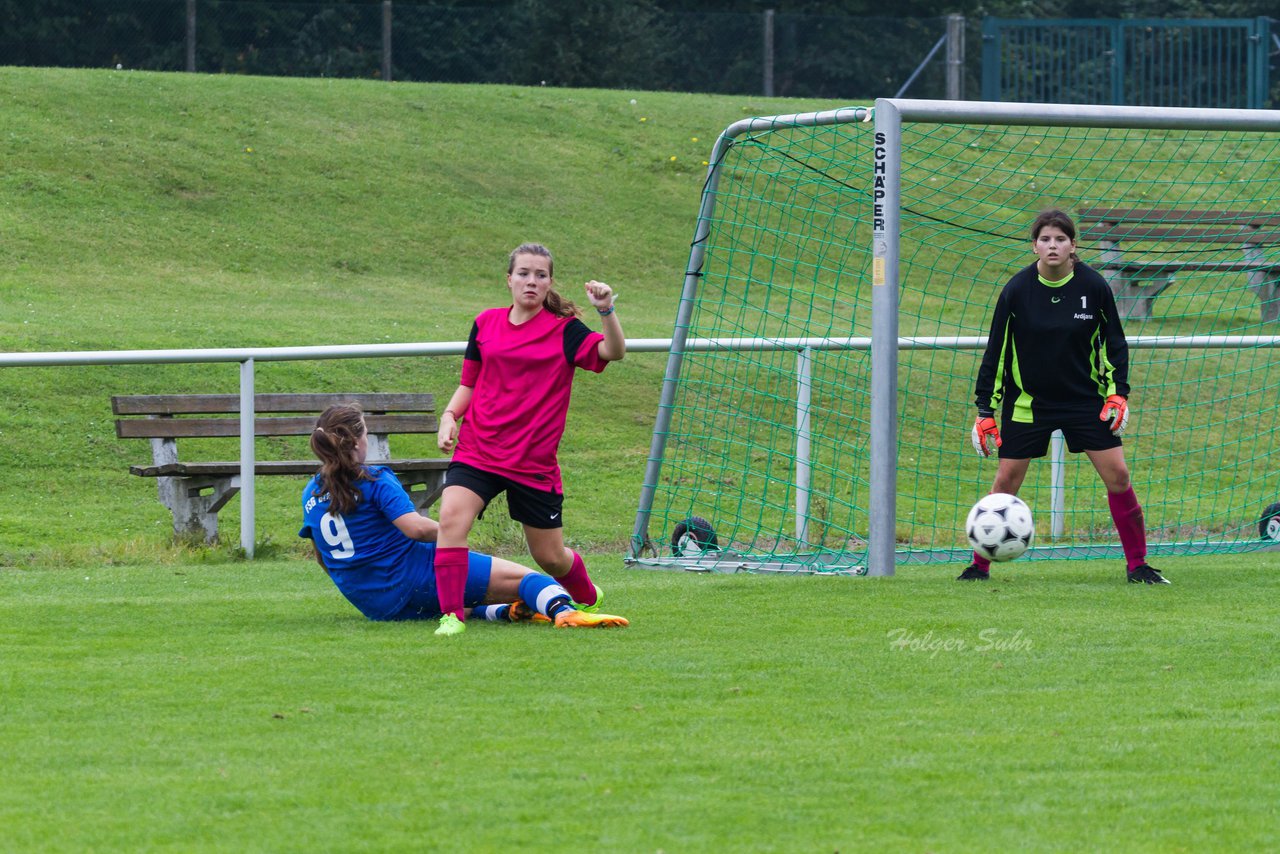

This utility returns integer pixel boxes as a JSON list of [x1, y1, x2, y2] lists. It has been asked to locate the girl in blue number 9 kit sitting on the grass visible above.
[[298, 405, 627, 635]]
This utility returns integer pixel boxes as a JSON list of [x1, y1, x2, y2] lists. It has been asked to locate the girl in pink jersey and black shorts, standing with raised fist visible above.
[[435, 243, 626, 634]]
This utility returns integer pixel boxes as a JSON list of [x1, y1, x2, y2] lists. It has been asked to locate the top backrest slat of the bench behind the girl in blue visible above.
[[111, 392, 435, 416]]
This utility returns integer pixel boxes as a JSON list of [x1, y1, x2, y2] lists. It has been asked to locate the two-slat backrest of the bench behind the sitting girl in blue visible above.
[[111, 392, 439, 439]]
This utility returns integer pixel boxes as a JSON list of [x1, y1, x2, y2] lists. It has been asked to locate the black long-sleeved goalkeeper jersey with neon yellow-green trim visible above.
[[974, 262, 1129, 424]]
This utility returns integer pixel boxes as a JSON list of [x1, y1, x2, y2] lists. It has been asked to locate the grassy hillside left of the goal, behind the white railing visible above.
[[0, 69, 860, 565]]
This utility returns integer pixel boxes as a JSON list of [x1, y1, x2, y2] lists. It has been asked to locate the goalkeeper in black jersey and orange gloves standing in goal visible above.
[[959, 209, 1169, 584]]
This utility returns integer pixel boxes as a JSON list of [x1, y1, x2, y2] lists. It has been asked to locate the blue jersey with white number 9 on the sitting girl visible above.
[[298, 466, 435, 620]]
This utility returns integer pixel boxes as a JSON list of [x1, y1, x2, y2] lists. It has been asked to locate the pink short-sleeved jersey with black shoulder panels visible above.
[[453, 307, 608, 494]]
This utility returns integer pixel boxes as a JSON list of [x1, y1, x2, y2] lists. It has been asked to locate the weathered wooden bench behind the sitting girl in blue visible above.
[[111, 393, 449, 543]]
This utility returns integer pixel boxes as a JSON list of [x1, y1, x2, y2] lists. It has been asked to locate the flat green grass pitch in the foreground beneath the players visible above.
[[0, 556, 1280, 851]]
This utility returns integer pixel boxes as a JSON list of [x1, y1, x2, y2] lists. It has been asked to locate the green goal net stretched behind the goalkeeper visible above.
[[632, 108, 1280, 572]]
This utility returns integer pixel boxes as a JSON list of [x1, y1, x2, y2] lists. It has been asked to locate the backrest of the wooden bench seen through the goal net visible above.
[[1076, 207, 1280, 246]]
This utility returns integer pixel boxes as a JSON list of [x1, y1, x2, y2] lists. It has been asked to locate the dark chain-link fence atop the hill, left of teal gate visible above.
[[0, 0, 979, 100]]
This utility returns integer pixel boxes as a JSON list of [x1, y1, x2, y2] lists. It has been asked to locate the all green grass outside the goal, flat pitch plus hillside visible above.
[[0, 69, 1280, 851]]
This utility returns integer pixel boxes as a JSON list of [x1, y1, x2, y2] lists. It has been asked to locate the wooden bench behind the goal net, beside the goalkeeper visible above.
[[1076, 207, 1280, 323]]
